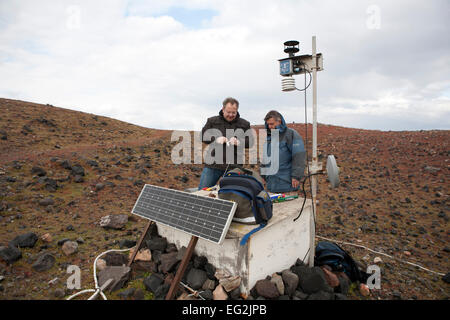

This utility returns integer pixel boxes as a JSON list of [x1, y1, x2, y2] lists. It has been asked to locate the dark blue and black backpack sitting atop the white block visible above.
[[218, 168, 272, 225]]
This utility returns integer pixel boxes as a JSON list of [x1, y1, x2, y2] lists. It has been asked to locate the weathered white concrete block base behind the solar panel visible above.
[[157, 191, 312, 295]]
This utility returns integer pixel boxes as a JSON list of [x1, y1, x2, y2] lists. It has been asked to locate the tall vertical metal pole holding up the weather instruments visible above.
[[309, 36, 318, 267]]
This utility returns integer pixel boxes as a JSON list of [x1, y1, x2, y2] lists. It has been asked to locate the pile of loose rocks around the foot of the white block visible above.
[[105, 227, 350, 300]]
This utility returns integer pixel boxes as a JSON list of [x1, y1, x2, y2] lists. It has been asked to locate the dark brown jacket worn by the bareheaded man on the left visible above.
[[202, 110, 253, 170]]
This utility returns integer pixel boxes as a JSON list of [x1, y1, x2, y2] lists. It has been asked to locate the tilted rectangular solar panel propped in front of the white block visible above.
[[131, 184, 236, 244]]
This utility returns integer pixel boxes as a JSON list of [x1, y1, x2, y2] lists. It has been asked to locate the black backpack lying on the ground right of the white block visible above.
[[314, 241, 369, 283]]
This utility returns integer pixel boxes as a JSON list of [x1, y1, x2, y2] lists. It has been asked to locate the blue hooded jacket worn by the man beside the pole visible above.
[[261, 116, 306, 192]]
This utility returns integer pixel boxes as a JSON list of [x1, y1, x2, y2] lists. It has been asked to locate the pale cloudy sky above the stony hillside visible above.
[[0, 0, 450, 130]]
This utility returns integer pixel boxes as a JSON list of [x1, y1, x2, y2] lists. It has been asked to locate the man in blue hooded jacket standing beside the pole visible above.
[[261, 110, 306, 193]]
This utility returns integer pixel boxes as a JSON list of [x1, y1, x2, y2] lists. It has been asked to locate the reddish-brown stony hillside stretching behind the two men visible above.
[[0, 99, 450, 299]]
